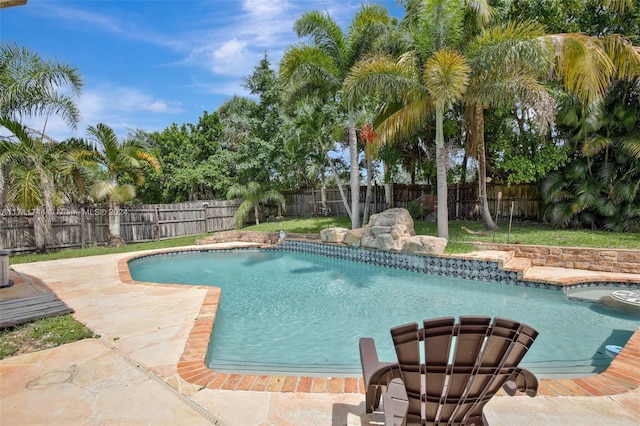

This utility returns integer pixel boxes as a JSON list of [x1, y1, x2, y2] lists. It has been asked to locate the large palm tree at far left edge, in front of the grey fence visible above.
[[0, 43, 82, 251]]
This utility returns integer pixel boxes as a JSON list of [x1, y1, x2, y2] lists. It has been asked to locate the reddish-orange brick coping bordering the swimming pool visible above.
[[118, 245, 640, 396]]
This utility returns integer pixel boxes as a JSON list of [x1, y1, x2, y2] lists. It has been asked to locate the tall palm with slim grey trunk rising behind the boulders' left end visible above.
[[280, 4, 391, 229]]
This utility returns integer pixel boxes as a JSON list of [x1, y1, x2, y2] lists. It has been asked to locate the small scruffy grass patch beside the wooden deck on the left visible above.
[[0, 314, 99, 359]]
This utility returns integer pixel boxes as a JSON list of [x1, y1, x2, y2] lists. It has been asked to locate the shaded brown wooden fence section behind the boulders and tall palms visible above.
[[283, 182, 540, 220]]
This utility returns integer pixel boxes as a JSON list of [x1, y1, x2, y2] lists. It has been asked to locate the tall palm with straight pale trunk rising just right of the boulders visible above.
[[344, 0, 481, 238]]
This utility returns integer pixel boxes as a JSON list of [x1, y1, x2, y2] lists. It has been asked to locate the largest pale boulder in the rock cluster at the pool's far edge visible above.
[[361, 208, 416, 251]]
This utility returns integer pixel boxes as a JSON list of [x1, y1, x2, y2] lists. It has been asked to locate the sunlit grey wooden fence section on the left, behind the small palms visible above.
[[0, 200, 240, 252]]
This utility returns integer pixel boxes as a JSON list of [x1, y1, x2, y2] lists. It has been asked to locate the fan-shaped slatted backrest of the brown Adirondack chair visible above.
[[391, 316, 538, 424]]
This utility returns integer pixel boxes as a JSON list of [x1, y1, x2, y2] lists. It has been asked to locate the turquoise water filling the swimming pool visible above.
[[129, 249, 639, 377]]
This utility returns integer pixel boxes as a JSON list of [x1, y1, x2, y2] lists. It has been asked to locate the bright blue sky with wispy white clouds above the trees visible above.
[[0, 0, 402, 140]]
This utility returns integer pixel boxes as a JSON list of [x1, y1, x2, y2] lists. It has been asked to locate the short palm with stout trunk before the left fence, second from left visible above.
[[79, 123, 161, 246]]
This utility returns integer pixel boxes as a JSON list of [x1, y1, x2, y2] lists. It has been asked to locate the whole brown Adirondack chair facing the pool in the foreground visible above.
[[360, 316, 538, 426]]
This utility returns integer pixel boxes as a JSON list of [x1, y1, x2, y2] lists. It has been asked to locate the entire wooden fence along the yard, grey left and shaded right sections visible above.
[[0, 182, 541, 252]]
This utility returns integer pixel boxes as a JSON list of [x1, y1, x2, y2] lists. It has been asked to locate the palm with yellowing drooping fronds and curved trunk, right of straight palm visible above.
[[464, 22, 556, 230]]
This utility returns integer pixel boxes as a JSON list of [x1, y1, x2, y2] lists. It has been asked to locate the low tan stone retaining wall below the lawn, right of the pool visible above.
[[474, 243, 640, 274]]
